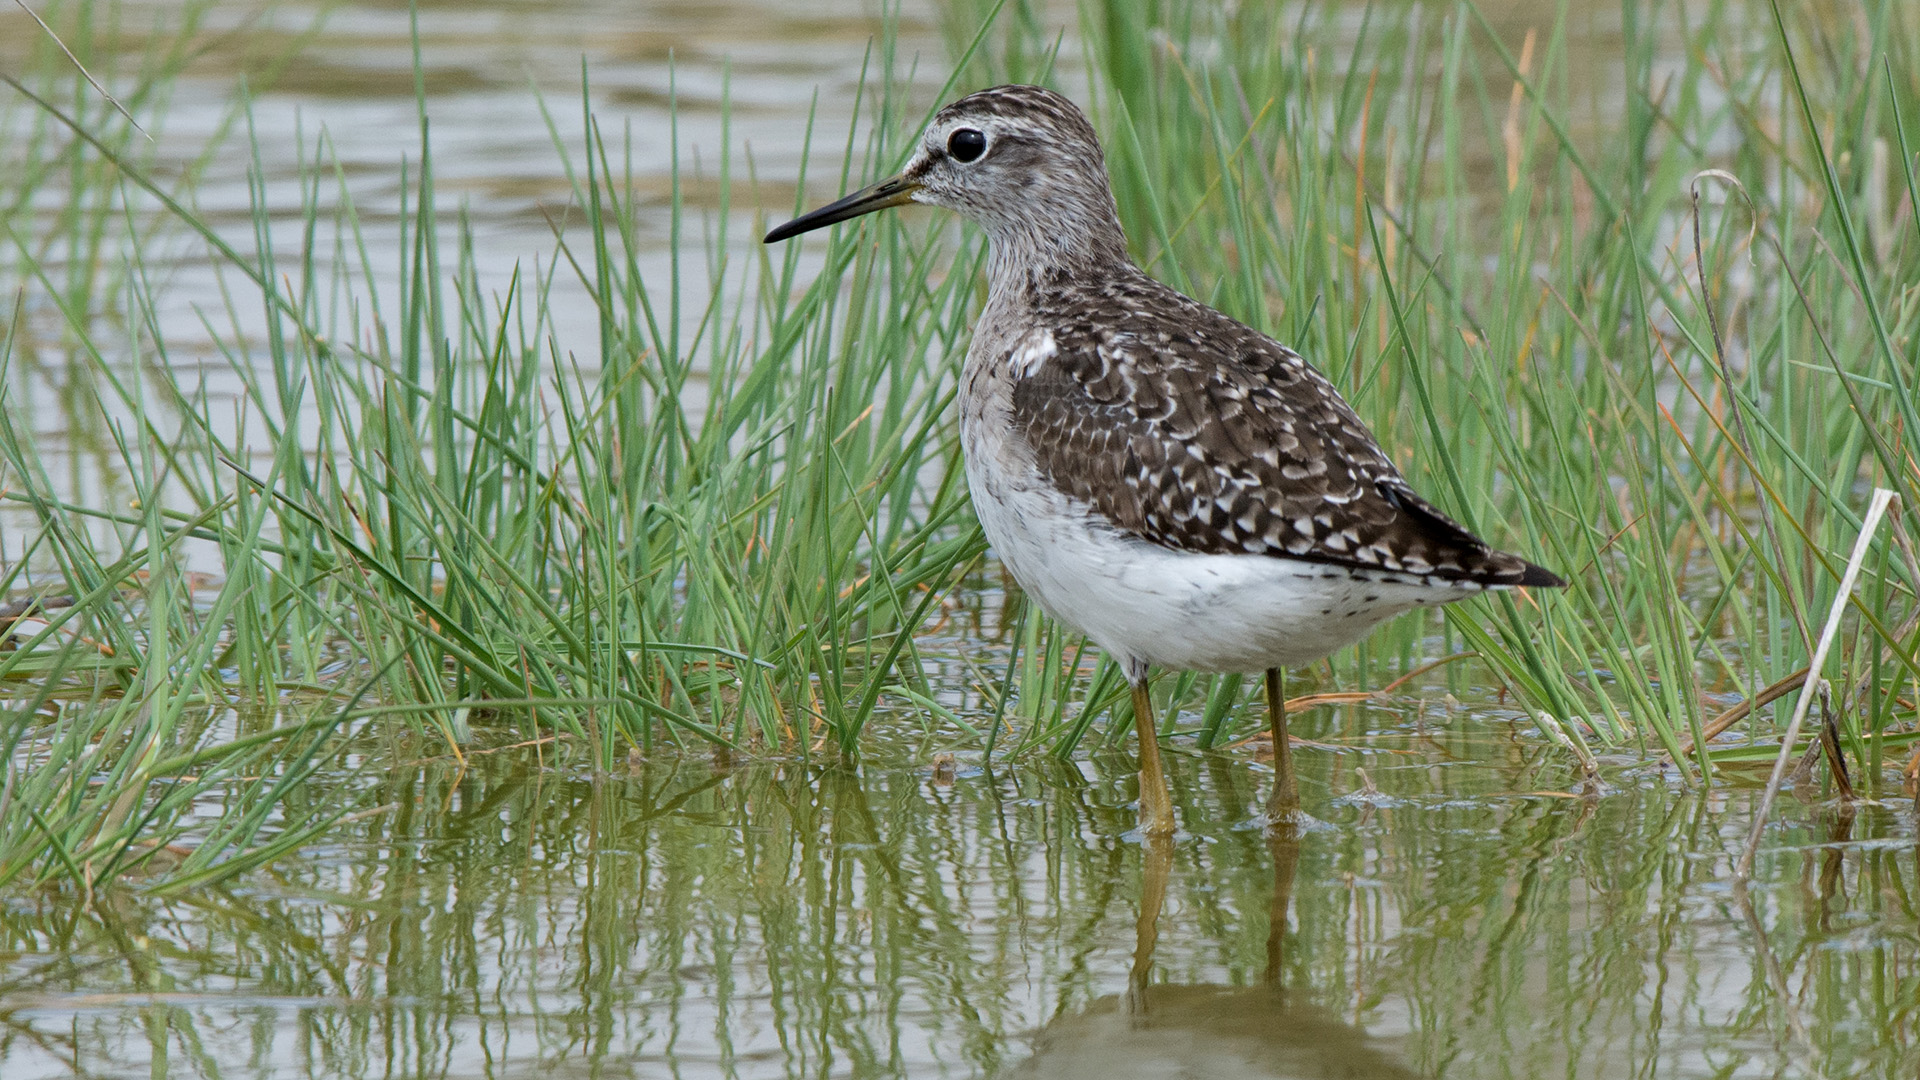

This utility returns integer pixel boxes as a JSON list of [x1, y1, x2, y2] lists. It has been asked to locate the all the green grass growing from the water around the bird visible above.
[[0, 0, 1920, 888]]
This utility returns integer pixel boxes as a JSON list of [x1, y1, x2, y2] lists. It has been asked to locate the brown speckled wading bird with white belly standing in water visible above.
[[766, 86, 1565, 836]]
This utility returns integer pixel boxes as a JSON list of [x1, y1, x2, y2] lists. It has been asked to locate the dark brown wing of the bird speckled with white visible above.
[[1008, 298, 1559, 584]]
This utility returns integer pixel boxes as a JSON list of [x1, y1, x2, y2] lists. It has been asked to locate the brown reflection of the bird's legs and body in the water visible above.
[[1002, 830, 1419, 1080]]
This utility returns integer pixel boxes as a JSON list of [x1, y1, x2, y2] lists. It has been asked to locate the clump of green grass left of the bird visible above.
[[0, 4, 979, 880]]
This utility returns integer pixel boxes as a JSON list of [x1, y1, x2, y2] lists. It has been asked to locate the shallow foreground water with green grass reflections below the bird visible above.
[[0, 709, 1920, 1080]]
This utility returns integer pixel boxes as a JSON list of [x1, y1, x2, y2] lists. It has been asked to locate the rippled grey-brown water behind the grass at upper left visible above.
[[0, 0, 947, 557]]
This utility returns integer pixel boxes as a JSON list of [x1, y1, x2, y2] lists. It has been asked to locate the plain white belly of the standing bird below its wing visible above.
[[968, 446, 1482, 676]]
